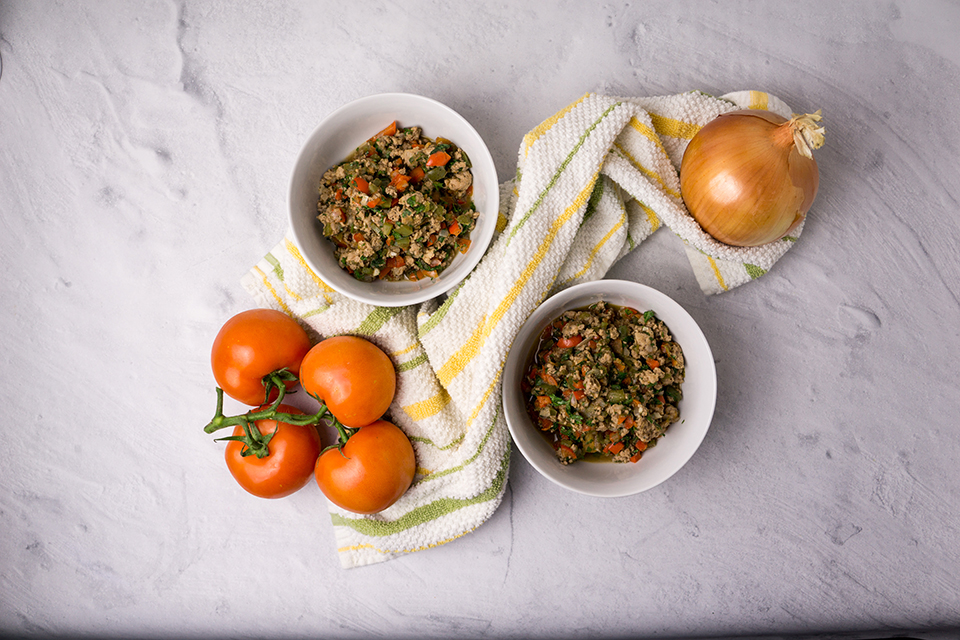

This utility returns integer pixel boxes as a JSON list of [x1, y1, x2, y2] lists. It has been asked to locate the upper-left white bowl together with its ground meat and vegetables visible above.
[[288, 93, 500, 307]]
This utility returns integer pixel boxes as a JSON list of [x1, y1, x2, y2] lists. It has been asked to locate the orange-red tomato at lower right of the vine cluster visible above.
[[316, 420, 417, 513]]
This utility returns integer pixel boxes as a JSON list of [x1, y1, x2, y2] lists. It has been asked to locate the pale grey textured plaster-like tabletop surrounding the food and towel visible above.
[[0, 0, 960, 638]]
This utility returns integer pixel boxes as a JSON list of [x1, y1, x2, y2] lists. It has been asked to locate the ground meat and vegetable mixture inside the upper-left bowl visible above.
[[317, 122, 478, 282]]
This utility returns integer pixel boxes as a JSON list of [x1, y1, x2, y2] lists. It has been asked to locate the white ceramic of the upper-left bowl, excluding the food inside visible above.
[[287, 93, 500, 307]]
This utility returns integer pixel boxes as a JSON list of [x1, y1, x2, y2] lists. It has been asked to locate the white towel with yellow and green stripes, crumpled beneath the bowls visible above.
[[242, 91, 800, 567]]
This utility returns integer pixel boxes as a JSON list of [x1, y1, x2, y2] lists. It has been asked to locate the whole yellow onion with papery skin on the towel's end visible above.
[[680, 109, 824, 247]]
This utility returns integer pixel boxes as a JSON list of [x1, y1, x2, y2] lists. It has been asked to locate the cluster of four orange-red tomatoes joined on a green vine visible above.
[[204, 309, 416, 513]]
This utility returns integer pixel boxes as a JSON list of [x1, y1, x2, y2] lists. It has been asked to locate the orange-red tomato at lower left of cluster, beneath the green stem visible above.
[[224, 404, 320, 498]]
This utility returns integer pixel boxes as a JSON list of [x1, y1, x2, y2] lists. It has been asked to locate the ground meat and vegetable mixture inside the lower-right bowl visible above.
[[523, 302, 684, 464]]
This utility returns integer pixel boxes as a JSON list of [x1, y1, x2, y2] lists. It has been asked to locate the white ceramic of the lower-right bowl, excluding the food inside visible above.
[[503, 280, 717, 498]]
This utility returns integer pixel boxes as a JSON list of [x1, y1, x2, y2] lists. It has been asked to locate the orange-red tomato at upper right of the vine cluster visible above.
[[300, 336, 397, 427]]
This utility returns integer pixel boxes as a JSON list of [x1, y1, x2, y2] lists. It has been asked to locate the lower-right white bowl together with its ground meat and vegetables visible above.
[[503, 280, 717, 498]]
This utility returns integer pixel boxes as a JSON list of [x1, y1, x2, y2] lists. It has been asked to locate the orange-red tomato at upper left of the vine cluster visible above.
[[210, 309, 310, 406]]
